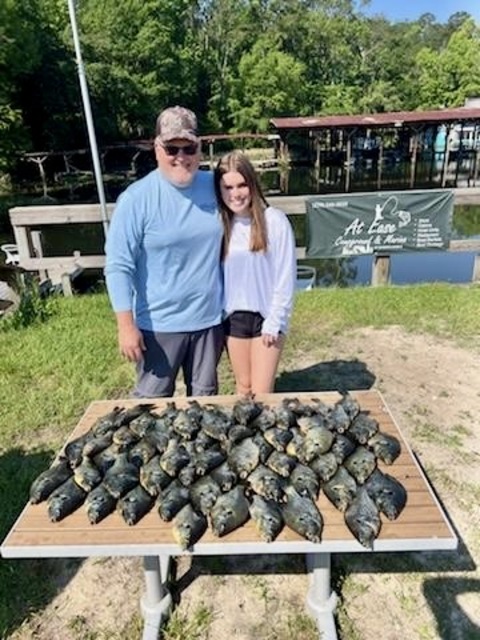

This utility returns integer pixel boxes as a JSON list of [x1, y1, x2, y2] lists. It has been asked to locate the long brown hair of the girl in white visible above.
[[214, 151, 268, 258]]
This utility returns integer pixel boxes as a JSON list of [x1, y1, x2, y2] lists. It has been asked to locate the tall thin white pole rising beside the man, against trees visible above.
[[68, 0, 108, 237]]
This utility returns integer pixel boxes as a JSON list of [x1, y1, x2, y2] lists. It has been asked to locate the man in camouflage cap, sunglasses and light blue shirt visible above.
[[105, 106, 223, 397]]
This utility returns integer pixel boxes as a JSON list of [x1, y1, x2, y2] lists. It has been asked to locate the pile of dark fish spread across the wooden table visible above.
[[30, 393, 407, 549]]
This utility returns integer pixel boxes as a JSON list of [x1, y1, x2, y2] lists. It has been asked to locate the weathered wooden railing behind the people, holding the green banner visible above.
[[10, 188, 480, 294]]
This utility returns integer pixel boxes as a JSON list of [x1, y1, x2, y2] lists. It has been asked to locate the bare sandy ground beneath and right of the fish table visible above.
[[10, 328, 480, 640]]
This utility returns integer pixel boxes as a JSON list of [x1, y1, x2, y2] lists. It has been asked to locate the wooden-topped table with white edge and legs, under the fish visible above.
[[1, 390, 458, 640]]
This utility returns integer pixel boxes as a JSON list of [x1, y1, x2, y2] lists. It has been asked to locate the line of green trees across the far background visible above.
[[0, 0, 480, 172]]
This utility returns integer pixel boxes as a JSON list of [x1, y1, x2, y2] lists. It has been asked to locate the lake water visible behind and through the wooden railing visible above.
[[0, 162, 480, 287]]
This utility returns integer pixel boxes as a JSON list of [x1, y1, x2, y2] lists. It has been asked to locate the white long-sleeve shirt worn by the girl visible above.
[[223, 207, 296, 335]]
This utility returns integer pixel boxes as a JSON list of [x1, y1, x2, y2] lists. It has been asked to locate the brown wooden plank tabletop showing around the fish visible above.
[[3, 390, 456, 557]]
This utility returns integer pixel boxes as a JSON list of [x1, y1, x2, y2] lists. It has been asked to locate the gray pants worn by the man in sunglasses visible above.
[[133, 324, 224, 398]]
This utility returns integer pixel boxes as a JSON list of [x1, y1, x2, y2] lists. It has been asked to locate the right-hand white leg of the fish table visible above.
[[306, 553, 337, 640]]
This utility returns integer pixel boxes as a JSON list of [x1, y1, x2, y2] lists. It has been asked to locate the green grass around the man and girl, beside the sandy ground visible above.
[[0, 284, 480, 638]]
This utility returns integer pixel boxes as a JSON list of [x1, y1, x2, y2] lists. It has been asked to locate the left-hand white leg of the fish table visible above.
[[140, 556, 172, 640]]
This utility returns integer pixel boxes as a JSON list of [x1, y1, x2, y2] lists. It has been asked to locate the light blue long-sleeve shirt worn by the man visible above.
[[105, 169, 222, 332]]
